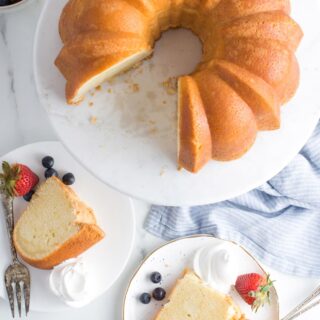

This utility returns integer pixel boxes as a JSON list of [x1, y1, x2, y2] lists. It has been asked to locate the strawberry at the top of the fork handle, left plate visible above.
[[0, 161, 39, 197]]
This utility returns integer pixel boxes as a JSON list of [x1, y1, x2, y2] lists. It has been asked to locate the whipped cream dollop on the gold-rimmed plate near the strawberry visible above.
[[193, 243, 238, 294]]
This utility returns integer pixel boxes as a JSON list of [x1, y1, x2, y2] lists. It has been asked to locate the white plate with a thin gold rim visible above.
[[123, 235, 279, 320]]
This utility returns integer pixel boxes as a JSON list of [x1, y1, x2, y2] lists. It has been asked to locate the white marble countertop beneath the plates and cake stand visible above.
[[0, 0, 320, 320]]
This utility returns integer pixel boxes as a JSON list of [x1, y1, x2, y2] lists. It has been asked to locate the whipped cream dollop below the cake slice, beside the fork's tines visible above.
[[49, 258, 91, 308]]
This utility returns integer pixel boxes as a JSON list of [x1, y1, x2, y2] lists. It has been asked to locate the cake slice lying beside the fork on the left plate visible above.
[[13, 177, 104, 269]]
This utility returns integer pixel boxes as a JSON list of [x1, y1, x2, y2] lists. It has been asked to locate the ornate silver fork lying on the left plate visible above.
[[0, 193, 31, 318]]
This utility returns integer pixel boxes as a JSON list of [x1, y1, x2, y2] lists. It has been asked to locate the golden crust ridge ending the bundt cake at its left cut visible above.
[[55, 31, 150, 103]]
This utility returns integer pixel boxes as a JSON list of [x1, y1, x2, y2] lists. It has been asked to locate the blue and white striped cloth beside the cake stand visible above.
[[145, 123, 320, 277]]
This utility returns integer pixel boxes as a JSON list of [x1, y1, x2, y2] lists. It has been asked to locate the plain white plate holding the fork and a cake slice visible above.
[[0, 142, 135, 312]]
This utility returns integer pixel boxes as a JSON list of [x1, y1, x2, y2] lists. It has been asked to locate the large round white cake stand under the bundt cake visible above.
[[34, 0, 320, 205]]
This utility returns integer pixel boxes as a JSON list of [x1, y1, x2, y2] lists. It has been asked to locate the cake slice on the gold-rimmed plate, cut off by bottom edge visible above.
[[155, 270, 245, 320]]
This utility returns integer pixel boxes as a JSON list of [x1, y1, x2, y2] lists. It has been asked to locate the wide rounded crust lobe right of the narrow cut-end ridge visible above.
[[195, 70, 257, 161]]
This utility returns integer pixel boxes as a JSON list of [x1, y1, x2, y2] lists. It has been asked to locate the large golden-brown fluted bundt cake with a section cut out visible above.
[[56, 0, 303, 172]]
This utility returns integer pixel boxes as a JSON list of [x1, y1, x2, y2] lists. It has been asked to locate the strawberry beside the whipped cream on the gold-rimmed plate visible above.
[[235, 273, 273, 312]]
